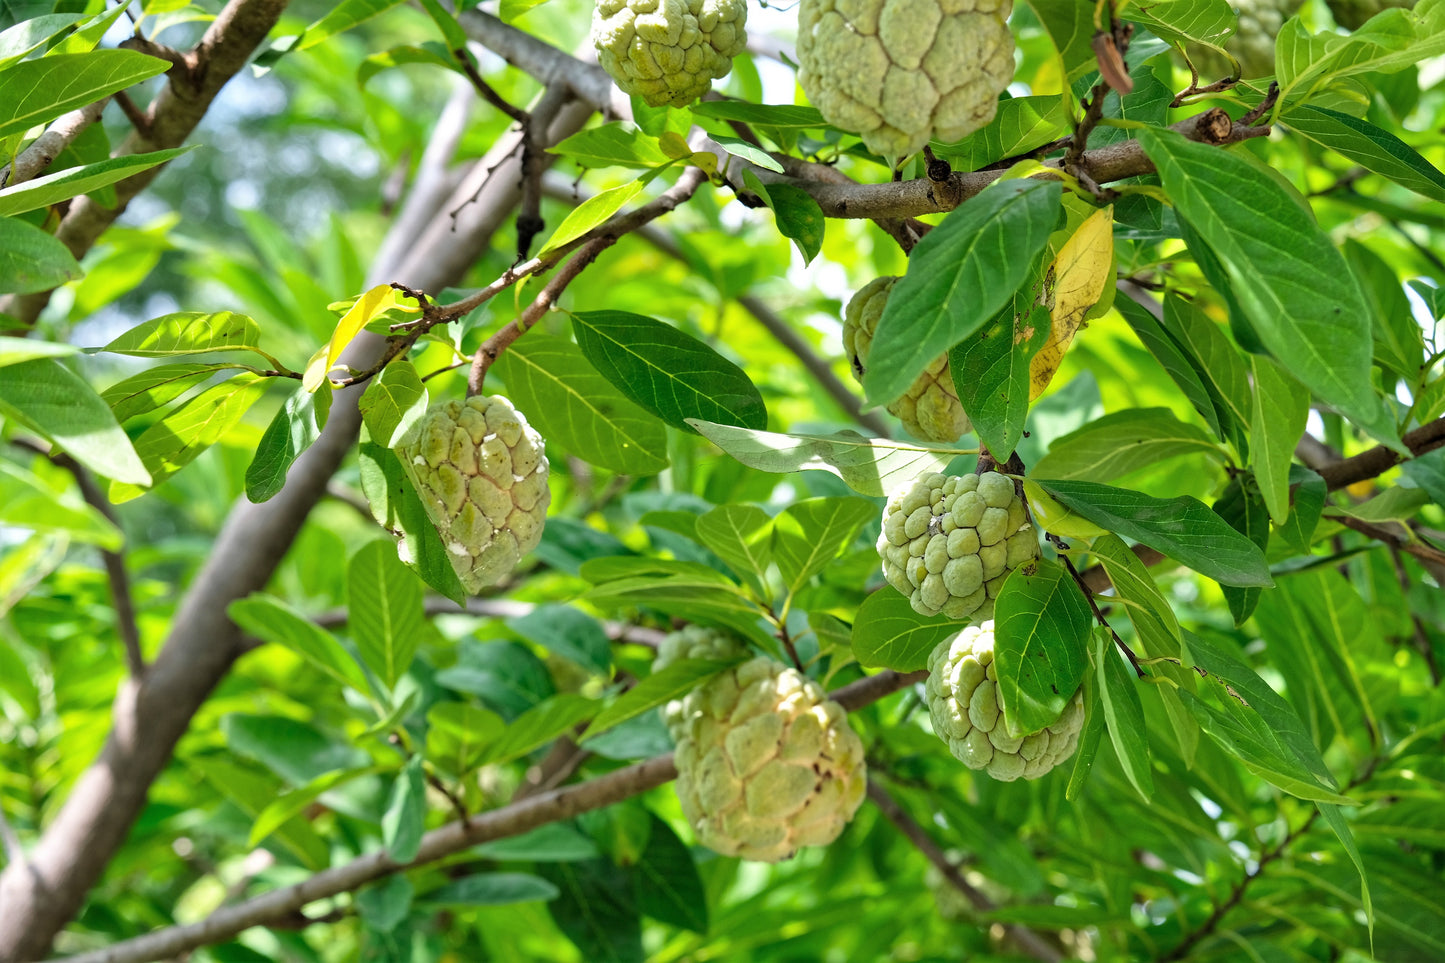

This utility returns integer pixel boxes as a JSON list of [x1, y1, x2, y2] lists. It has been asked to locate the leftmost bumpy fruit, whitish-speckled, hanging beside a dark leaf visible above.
[[396, 395, 552, 594]]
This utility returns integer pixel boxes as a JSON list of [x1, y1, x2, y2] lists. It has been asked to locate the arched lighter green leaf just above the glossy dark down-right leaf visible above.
[[1034, 408, 1225, 482]]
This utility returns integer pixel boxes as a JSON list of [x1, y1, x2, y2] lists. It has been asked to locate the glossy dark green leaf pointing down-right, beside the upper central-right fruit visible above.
[[1035, 479, 1274, 586]]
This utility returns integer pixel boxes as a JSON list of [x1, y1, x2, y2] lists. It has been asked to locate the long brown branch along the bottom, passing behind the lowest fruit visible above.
[[45, 671, 926, 963]]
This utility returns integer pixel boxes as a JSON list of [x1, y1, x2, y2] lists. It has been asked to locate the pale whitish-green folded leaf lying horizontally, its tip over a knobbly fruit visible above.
[[689, 419, 967, 496]]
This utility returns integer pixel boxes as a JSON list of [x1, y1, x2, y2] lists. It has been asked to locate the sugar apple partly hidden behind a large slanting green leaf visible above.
[[842, 278, 971, 441]]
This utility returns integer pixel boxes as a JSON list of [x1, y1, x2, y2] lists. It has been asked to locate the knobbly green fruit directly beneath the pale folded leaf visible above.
[[879, 471, 1039, 622]]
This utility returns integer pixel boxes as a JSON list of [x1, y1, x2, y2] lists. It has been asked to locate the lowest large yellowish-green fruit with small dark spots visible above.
[[676, 658, 868, 863]]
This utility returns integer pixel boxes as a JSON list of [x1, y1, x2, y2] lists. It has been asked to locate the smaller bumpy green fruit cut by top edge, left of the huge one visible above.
[[592, 0, 747, 107]]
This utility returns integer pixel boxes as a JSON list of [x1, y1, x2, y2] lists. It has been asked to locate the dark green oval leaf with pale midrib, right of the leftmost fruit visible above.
[[572, 311, 767, 431]]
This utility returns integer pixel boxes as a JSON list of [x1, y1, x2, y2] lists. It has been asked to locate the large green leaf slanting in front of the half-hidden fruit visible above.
[[863, 179, 1061, 405]]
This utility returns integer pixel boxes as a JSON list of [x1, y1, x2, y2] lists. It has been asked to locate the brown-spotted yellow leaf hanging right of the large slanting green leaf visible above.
[[1029, 207, 1114, 401]]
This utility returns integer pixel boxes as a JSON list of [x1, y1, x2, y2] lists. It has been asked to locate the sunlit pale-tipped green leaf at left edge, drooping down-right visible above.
[[0, 357, 150, 484]]
